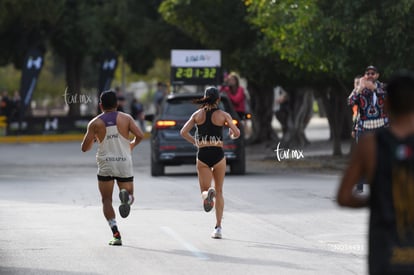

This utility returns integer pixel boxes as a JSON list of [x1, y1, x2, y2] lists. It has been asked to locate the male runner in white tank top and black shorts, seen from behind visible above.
[[82, 90, 144, 245]]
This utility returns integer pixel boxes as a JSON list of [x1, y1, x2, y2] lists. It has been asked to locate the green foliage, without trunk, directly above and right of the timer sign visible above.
[[159, 0, 280, 85]]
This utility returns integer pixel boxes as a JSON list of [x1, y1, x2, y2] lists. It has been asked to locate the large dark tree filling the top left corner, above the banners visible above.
[[0, 0, 103, 115]]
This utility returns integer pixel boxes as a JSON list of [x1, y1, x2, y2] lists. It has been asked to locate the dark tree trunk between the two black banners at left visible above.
[[65, 53, 83, 116]]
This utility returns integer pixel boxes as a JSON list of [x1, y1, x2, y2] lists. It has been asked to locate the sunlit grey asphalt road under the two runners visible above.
[[0, 140, 368, 275]]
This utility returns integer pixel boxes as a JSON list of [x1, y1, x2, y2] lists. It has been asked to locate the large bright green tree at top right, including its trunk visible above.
[[245, 0, 414, 154]]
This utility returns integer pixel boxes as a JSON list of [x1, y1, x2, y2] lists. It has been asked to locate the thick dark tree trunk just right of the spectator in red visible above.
[[248, 81, 279, 144]]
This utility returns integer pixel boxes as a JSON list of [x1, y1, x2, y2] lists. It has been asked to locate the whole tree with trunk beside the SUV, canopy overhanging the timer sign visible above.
[[160, 0, 286, 146]]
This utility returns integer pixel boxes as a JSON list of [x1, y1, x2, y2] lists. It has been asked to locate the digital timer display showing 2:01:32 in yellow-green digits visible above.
[[171, 67, 220, 85]]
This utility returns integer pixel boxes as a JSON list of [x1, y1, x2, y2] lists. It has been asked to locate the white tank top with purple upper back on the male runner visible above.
[[96, 112, 133, 178]]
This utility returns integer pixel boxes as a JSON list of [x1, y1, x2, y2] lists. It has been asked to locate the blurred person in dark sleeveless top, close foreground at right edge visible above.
[[337, 72, 414, 274]]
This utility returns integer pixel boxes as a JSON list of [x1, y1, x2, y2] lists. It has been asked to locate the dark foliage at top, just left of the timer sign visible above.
[[112, 0, 195, 75]]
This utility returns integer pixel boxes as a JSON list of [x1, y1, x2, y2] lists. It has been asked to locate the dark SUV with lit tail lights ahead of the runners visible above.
[[151, 94, 246, 176]]
